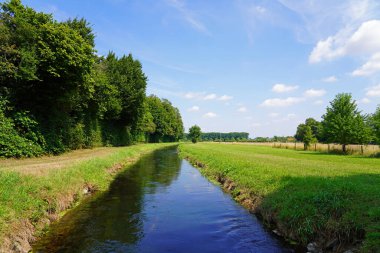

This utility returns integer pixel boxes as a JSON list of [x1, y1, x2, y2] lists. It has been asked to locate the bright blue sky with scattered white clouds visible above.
[[23, 0, 380, 137]]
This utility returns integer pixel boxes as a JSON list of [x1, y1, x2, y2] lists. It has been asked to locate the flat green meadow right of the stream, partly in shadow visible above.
[[180, 143, 380, 252]]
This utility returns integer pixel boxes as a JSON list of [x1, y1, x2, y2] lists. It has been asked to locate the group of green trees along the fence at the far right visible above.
[[295, 93, 380, 152]]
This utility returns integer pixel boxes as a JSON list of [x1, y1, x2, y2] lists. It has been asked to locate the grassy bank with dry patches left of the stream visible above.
[[0, 144, 173, 252]]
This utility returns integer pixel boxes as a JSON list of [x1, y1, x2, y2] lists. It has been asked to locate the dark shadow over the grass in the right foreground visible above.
[[260, 174, 380, 252]]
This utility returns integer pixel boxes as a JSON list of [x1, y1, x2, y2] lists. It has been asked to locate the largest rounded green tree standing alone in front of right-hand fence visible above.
[[322, 93, 371, 153]]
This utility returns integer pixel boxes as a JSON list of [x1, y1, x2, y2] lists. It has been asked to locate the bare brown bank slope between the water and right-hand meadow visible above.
[[185, 156, 364, 253]]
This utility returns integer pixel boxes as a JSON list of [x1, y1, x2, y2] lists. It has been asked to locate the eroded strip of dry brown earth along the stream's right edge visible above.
[[179, 149, 361, 253]]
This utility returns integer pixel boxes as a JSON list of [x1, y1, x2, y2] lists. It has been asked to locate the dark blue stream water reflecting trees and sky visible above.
[[34, 149, 292, 253]]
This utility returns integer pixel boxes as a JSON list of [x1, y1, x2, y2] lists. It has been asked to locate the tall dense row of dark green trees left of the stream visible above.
[[0, 0, 183, 157]]
